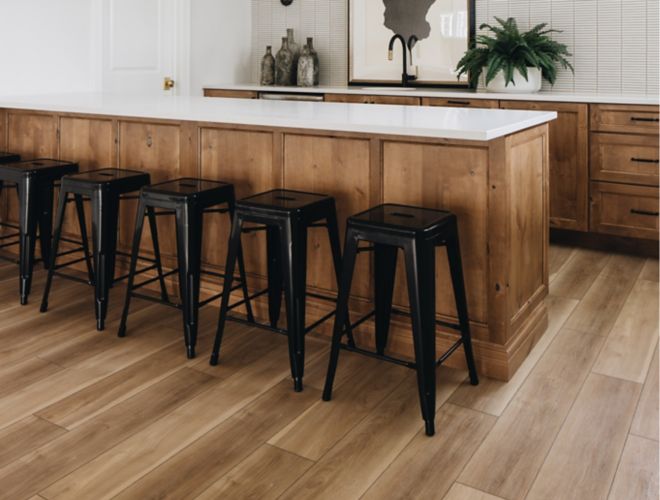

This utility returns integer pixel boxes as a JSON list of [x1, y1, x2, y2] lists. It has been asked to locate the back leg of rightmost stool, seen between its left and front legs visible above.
[[374, 244, 398, 355]]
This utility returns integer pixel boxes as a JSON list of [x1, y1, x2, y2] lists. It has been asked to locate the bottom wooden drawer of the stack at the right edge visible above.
[[591, 182, 658, 240]]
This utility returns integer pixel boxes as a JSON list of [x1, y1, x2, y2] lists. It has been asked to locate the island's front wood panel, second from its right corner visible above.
[[284, 134, 372, 297]]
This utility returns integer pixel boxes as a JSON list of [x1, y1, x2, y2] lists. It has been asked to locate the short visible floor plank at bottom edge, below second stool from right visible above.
[[197, 444, 313, 500]]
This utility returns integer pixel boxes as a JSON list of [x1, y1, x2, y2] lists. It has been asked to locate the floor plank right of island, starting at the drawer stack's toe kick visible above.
[[566, 255, 645, 336]]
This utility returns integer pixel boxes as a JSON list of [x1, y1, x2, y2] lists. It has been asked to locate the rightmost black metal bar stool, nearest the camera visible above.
[[323, 204, 479, 436]]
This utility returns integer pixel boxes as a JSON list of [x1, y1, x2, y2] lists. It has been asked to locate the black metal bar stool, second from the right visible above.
[[211, 189, 350, 391]]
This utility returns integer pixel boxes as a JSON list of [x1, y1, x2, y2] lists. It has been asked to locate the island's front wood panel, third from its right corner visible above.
[[200, 128, 282, 276]]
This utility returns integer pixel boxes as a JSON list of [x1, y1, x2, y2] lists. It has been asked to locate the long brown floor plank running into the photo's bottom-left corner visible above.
[[0, 368, 218, 500]]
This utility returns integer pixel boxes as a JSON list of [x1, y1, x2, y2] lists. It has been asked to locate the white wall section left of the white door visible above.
[[0, 0, 97, 95]]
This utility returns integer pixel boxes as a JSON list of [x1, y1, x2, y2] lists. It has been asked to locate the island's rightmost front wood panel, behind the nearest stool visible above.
[[383, 142, 488, 322]]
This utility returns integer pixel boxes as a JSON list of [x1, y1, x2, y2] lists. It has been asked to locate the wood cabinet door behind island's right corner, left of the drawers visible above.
[[500, 101, 589, 231]]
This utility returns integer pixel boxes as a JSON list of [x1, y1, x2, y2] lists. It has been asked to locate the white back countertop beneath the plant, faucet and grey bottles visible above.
[[204, 83, 660, 105]]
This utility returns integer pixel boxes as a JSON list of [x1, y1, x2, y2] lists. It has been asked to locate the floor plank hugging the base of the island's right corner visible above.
[[449, 295, 578, 416]]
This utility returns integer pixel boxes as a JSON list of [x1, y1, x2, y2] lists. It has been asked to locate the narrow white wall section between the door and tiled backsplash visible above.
[[192, 0, 252, 95]]
